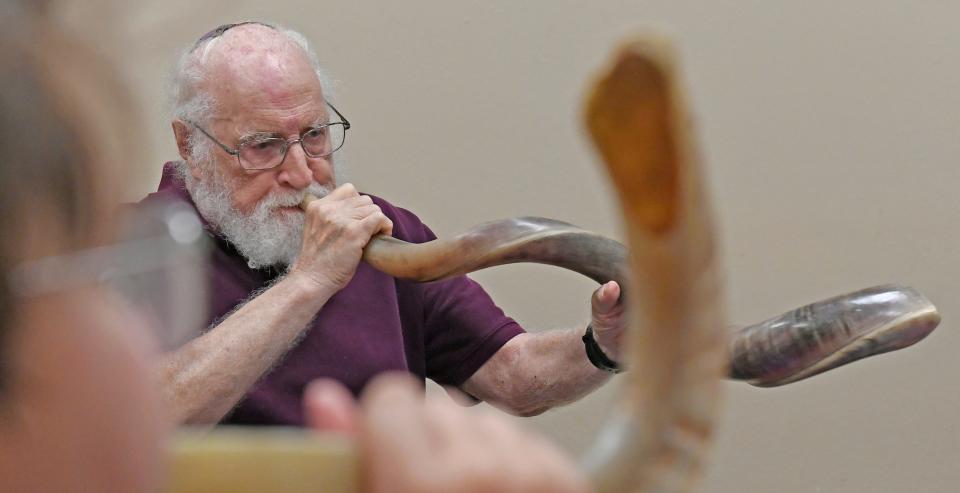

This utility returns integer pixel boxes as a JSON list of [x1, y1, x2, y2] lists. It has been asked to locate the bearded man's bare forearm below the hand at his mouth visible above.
[[160, 274, 336, 424]]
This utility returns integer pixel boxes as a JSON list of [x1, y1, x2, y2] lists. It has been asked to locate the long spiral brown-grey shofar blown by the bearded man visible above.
[[352, 217, 940, 387]]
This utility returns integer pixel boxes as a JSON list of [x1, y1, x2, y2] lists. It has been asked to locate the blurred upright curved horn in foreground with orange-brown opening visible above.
[[586, 35, 728, 492]]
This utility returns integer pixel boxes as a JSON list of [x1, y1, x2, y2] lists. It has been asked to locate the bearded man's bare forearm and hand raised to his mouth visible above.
[[160, 185, 393, 425]]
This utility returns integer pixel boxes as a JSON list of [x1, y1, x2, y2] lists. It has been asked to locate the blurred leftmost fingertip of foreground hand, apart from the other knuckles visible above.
[[303, 379, 358, 436]]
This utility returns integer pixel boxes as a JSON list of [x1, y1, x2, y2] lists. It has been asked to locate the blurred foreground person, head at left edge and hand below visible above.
[[0, 10, 589, 493]]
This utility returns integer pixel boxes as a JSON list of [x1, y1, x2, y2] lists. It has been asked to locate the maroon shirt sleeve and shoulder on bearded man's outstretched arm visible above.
[[376, 199, 524, 387]]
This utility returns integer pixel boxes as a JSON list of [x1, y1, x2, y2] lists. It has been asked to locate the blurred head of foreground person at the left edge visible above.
[[0, 13, 164, 492]]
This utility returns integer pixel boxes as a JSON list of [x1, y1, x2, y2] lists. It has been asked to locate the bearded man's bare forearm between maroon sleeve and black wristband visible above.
[[463, 329, 611, 416]]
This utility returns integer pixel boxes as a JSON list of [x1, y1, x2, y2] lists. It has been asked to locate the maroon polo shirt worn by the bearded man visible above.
[[144, 163, 523, 425]]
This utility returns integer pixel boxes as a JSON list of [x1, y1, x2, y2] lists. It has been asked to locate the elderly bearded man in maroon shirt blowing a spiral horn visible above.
[[147, 22, 623, 425]]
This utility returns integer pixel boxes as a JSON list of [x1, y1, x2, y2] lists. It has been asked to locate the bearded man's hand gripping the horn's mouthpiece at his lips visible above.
[[290, 183, 393, 291]]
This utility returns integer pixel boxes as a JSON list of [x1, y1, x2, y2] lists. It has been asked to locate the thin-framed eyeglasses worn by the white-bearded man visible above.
[[187, 103, 350, 171]]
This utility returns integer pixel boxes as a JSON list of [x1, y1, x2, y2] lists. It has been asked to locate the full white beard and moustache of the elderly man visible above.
[[184, 161, 332, 269]]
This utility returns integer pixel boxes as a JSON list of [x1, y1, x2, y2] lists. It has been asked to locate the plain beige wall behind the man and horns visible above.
[[58, 0, 960, 493]]
